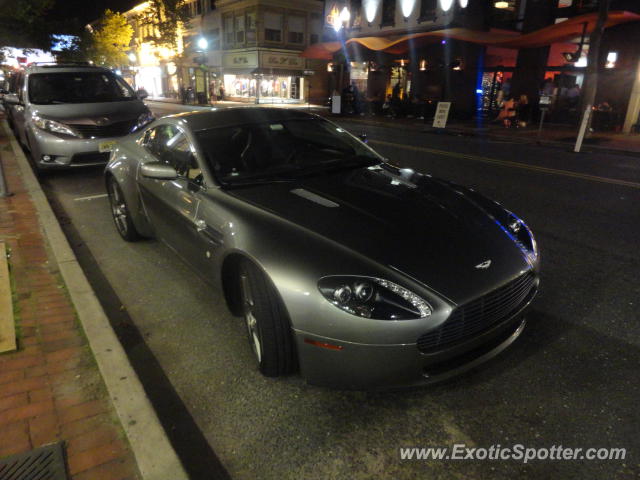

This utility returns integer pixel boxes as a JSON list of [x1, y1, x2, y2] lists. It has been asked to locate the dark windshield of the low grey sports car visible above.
[[196, 118, 383, 185]]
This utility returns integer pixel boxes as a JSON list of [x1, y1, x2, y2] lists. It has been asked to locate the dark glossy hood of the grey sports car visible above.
[[230, 167, 529, 303]]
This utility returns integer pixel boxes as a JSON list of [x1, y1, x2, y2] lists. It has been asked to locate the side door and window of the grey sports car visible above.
[[138, 124, 204, 267]]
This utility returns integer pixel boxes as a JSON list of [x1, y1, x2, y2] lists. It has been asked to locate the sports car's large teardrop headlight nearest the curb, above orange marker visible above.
[[318, 276, 433, 320]]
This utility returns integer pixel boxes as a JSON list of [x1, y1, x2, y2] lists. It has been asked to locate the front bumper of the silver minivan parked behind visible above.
[[27, 126, 119, 169]]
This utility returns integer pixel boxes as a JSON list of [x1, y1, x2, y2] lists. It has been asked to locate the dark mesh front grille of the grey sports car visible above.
[[418, 271, 536, 353]]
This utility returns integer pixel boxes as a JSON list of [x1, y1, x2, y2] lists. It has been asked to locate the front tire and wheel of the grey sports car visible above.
[[239, 261, 297, 377]]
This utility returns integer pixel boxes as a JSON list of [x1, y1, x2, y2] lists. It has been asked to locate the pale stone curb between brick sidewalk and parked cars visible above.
[[2, 120, 189, 480]]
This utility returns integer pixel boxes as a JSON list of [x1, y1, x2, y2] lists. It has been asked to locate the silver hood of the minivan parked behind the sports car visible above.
[[32, 100, 148, 125]]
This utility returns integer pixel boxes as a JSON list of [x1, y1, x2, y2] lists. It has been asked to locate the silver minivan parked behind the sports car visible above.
[[4, 64, 153, 170]]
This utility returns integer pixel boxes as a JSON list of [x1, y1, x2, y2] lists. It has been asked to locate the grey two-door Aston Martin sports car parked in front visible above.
[[105, 107, 539, 389]]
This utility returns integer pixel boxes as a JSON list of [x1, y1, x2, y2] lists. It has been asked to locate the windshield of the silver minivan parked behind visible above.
[[29, 72, 135, 105]]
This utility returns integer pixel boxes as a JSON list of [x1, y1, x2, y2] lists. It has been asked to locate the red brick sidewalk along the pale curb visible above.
[[0, 123, 140, 480]]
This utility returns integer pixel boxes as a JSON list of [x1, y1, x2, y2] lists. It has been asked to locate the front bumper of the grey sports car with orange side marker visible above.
[[295, 307, 526, 390]]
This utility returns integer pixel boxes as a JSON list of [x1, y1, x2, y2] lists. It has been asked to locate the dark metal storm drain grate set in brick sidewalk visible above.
[[0, 443, 68, 480]]
